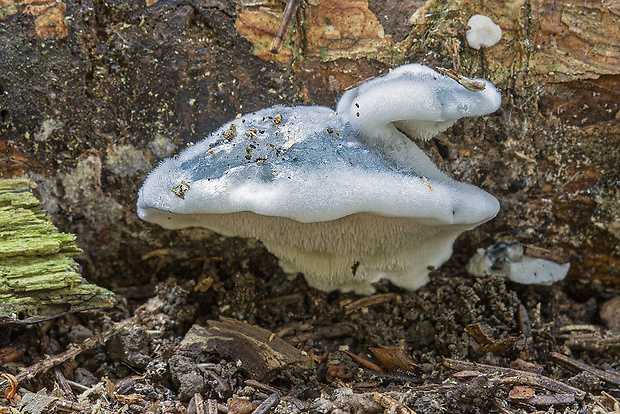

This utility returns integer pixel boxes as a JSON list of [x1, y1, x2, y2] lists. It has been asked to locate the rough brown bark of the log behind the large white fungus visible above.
[[0, 0, 620, 290]]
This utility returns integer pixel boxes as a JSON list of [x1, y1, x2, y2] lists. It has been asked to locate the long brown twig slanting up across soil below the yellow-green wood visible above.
[[16, 311, 151, 381]]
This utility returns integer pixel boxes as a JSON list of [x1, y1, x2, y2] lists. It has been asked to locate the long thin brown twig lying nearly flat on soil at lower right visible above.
[[443, 358, 586, 401]]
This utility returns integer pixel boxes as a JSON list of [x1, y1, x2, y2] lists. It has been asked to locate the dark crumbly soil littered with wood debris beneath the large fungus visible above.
[[1, 239, 620, 413]]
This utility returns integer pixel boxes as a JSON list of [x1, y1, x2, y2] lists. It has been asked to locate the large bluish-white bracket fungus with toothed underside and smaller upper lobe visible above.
[[137, 64, 501, 294]]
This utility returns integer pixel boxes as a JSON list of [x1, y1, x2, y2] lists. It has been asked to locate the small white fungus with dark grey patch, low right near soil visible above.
[[467, 240, 570, 285]]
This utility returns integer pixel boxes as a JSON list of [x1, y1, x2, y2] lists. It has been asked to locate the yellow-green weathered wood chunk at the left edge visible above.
[[0, 179, 114, 325]]
